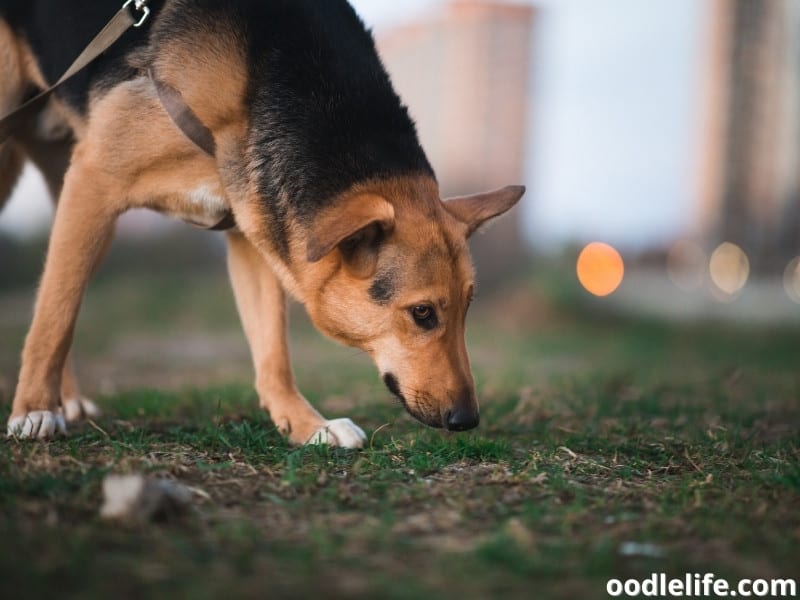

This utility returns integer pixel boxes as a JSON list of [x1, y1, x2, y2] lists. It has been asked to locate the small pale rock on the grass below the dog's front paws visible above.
[[100, 475, 192, 523]]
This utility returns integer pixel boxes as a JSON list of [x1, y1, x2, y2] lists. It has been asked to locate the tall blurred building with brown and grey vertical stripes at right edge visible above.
[[696, 0, 800, 272]]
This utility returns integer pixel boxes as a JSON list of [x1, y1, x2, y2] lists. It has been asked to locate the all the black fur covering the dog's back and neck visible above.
[[0, 0, 434, 257]]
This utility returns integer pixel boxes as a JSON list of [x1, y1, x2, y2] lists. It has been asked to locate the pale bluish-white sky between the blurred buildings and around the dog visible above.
[[0, 0, 703, 249]]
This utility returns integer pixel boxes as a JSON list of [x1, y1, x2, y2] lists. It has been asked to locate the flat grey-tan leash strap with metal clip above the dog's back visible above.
[[0, 0, 150, 144]]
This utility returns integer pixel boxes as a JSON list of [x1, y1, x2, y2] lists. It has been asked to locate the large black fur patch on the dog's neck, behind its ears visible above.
[[241, 0, 433, 253]]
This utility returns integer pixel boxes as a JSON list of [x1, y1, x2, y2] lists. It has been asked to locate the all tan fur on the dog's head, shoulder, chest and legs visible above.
[[0, 21, 521, 444]]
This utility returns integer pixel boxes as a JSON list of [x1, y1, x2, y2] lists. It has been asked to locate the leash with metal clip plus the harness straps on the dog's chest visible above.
[[0, 0, 236, 231]]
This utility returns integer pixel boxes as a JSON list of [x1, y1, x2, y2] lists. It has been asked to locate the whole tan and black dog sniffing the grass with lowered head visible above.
[[0, 0, 524, 448]]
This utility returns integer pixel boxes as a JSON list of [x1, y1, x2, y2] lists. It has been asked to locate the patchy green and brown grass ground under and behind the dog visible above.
[[0, 238, 800, 598]]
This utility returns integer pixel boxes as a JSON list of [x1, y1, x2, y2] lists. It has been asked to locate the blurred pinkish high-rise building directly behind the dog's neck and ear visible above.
[[378, 0, 534, 279]]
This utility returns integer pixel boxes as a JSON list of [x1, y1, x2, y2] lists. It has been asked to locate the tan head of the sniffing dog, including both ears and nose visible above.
[[296, 179, 525, 431]]
